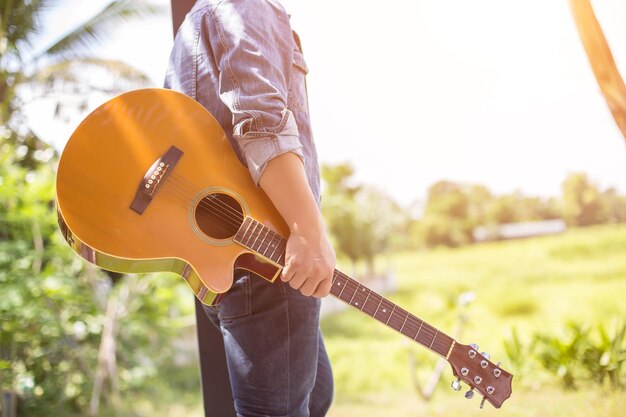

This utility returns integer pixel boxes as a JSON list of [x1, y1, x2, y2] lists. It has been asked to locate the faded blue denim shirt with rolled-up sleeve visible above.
[[164, 0, 320, 204]]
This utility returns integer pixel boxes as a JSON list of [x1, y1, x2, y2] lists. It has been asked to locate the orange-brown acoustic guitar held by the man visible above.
[[56, 89, 512, 408]]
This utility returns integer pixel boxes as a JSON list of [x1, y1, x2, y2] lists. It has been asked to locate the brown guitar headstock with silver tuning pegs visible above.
[[448, 343, 513, 408]]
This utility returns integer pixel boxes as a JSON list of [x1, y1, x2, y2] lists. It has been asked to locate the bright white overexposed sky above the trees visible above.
[[26, 0, 626, 205]]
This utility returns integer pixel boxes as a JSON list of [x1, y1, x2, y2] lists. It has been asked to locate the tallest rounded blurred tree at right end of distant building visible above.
[[562, 173, 607, 226]]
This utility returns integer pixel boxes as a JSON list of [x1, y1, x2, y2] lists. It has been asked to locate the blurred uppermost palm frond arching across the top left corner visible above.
[[37, 0, 166, 61]]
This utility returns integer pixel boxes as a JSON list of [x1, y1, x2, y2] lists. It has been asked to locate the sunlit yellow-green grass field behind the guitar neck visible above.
[[322, 225, 626, 417]]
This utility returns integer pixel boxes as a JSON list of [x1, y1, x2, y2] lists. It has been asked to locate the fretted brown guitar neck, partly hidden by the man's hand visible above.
[[234, 217, 456, 359]]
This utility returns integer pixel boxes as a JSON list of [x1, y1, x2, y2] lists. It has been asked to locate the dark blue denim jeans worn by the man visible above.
[[205, 272, 333, 417]]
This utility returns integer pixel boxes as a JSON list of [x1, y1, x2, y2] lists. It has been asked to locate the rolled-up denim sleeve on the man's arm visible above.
[[206, 0, 303, 185]]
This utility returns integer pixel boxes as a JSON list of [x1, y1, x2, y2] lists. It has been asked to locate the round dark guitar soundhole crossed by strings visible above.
[[195, 193, 243, 239]]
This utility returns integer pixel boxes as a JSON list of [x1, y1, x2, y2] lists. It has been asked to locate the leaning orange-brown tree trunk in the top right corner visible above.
[[569, 0, 626, 141]]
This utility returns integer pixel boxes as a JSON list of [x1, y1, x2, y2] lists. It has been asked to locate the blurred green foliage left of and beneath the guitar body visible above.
[[0, 139, 192, 416]]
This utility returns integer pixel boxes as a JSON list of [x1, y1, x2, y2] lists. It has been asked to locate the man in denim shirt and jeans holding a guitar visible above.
[[165, 0, 335, 417]]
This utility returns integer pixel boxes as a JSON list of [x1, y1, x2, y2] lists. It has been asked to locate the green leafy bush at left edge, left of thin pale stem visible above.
[[0, 141, 101, 415]]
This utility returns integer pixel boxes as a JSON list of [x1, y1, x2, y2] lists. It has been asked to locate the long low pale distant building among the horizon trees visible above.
[[472, 219, 567, 242]]
